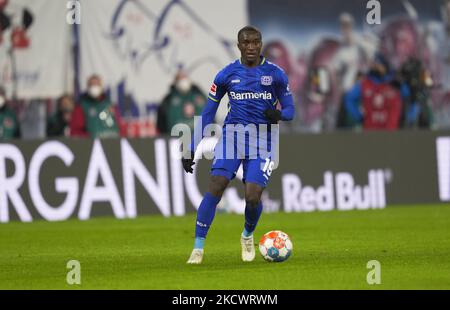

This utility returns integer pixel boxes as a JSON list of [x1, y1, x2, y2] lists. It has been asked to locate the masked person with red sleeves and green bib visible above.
[[70, 75, 120, 138]]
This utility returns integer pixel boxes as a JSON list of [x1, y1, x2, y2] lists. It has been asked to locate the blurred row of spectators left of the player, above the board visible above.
[[0, 70, 206, 139]]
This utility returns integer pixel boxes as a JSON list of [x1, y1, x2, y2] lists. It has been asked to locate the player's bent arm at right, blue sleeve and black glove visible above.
[[264, 71, 295, 124]]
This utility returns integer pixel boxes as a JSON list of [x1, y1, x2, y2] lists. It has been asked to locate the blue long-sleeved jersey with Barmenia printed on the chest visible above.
[[191, 57, 295, 151]]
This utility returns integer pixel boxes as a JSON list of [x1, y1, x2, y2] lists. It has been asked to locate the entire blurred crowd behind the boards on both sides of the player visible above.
[[0, 9, 450, 139]]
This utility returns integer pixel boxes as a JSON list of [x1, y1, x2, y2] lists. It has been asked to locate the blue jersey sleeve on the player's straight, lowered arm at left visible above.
[[190, 70, 227, 152]]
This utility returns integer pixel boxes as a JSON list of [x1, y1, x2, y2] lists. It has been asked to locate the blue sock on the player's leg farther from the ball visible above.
[[194, 193, 221, 249]]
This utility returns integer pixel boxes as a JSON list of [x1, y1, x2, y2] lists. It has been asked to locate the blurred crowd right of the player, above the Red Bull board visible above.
[[264, 12, 442, 132]]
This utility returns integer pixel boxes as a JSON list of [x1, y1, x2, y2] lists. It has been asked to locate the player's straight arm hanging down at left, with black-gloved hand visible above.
[[182, 72, 226, 173]]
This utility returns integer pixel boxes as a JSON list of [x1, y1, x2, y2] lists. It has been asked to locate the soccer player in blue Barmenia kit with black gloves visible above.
[[182, 26, 295, 264]]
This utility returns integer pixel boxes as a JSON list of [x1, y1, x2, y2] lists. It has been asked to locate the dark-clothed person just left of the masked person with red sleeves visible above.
[[47, 95, 75, 137]]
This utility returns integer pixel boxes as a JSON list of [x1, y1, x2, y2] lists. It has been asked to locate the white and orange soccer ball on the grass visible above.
[[259, 230, 292, 262]]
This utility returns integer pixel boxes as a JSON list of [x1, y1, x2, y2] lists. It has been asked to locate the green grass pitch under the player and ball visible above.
[[0, 205, 450, 289]]
